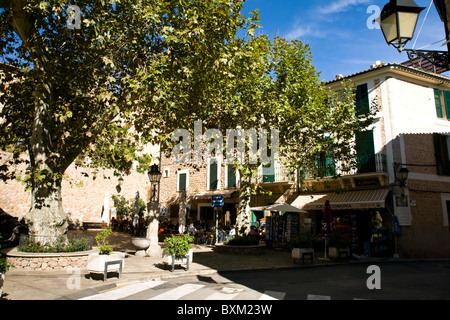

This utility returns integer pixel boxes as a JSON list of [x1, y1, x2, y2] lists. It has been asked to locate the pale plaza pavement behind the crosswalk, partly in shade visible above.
[[3, 231, 316, 300]]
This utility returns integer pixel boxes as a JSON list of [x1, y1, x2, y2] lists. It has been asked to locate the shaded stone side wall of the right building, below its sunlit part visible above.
[[398, 134, 450, 258]]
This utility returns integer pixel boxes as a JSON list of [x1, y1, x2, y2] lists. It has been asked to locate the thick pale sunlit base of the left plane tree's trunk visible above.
[[25, 172, 69, 237]]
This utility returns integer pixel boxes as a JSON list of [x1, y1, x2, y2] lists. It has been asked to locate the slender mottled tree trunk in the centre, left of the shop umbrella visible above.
[[236, 175, 252, 236]]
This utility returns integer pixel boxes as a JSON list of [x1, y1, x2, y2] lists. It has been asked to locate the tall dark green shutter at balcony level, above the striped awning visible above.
[[355, 130, 376, 173]]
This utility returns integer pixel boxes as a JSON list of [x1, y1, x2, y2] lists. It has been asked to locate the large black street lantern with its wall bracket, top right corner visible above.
[[380, 0, 450, 71]]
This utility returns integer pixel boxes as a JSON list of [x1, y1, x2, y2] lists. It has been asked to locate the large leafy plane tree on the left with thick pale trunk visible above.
[[0, 0, 254, 236]]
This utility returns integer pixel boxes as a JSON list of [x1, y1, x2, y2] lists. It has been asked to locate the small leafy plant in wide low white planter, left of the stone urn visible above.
[[87, 229, 125, 273]]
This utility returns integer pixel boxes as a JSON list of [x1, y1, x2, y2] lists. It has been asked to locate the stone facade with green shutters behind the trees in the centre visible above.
[[156, 151, 297, 230]]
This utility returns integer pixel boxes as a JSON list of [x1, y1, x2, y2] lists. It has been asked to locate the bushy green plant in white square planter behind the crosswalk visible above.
[[163, 233, 194, 271]]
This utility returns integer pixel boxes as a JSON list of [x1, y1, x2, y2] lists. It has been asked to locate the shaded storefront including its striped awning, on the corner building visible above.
[[292, 189, 392, 256]]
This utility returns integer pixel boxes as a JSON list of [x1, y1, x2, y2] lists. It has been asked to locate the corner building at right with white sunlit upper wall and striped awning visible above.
[[294, 64, 450, 258]]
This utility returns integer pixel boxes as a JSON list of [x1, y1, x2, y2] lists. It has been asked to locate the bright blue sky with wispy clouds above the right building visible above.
[[244, 0, 447, 81]]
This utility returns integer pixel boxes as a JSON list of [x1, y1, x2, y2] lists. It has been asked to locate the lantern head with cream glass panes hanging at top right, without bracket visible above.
[[380, 0, 425, 52]]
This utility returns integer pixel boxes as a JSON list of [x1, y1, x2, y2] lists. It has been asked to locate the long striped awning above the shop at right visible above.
[[292, 189, 389, 210]]
